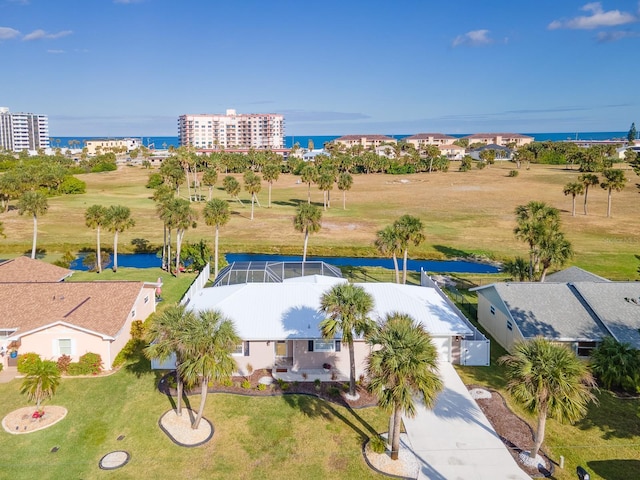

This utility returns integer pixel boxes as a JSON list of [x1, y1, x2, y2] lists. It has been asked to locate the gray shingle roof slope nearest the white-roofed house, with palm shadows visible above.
[[493, 282, 604, 341]]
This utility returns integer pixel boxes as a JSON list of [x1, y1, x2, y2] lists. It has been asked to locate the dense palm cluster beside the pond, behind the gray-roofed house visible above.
[[514, 201, 573, 282]]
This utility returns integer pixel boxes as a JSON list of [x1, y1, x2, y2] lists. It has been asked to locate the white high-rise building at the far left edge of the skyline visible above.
[[0, 107, 49, 152]]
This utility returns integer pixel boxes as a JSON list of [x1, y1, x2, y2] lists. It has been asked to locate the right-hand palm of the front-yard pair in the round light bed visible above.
[[179, 310, 240, 430]]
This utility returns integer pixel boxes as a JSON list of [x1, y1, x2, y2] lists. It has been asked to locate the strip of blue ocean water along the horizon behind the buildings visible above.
[[51, 132, 627, 149]]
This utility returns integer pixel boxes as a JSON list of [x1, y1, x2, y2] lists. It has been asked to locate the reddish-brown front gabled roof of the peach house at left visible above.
[[0, 281, 148, 337]]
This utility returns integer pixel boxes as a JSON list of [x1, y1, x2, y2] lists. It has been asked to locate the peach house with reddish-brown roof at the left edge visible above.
[[0, 257, 159, 370]]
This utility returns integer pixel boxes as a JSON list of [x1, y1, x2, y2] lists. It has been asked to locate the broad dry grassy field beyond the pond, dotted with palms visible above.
[[0, 162, 640, 280]]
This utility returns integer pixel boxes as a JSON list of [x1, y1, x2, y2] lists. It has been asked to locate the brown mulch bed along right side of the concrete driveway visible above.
[[467, 385, 554, 477]]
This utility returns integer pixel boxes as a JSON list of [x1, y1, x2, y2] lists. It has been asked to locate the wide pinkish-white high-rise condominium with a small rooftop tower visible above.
[[178, 110, 284, 150]]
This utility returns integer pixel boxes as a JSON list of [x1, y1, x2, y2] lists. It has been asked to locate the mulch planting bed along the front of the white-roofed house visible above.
[[158, 369, 378, 408]]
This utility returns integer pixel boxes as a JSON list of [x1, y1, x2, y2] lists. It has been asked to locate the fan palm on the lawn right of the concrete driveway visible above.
[[498, 337, 596, 458]]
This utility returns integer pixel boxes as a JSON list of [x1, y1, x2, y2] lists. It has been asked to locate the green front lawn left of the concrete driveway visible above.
[[0, 368, 387, 480]]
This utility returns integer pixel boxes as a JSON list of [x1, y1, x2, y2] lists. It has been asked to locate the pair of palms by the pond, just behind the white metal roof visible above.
[[375, 215, 425, 283]]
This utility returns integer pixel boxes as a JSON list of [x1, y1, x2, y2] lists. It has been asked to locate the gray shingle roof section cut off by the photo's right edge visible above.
[[574, 282, 640, 349]]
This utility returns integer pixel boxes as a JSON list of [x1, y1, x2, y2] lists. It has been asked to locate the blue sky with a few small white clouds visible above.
[[0, 0, 640, 136]]
